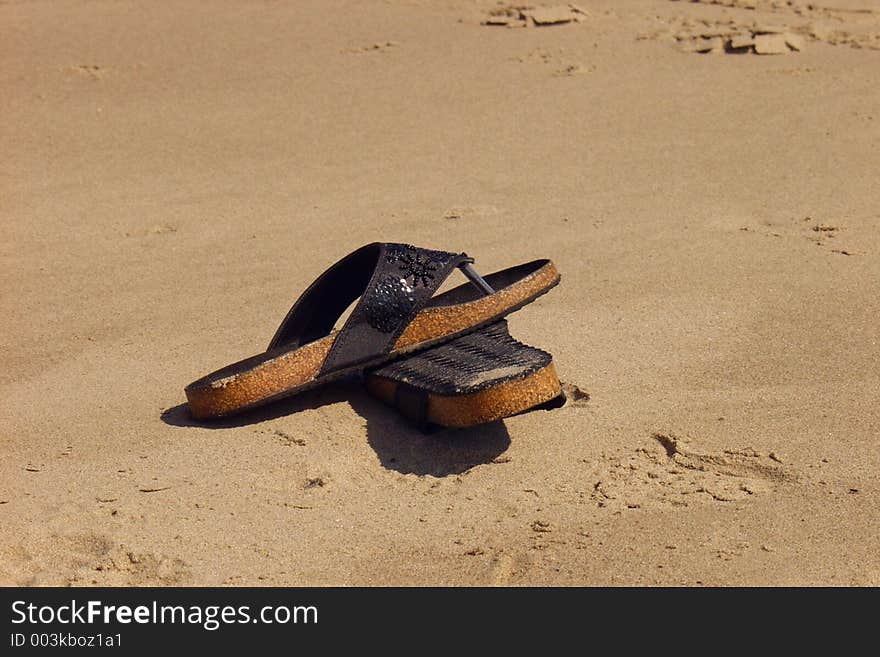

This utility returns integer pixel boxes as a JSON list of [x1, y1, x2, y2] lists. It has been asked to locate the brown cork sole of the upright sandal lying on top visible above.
[[185, 261, 560, 418]]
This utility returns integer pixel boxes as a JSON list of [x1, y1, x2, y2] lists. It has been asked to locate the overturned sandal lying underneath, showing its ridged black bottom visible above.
[[365, 320, 565, 431]]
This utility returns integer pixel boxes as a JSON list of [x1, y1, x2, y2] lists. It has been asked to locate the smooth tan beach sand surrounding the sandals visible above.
[[0, 0, 880, 585]]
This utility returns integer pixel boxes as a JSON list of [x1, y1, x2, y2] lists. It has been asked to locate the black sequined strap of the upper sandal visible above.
[[269, 242, 472, 374]]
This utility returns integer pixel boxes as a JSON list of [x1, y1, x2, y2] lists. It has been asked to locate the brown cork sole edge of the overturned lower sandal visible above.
[[366, 363, 562, 429]]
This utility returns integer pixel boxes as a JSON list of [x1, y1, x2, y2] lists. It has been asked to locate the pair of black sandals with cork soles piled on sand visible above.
[[186, 242, 564, 428]]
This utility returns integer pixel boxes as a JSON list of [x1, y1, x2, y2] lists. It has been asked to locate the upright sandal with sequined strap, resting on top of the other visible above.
[[186, 242, 560, 418]]
